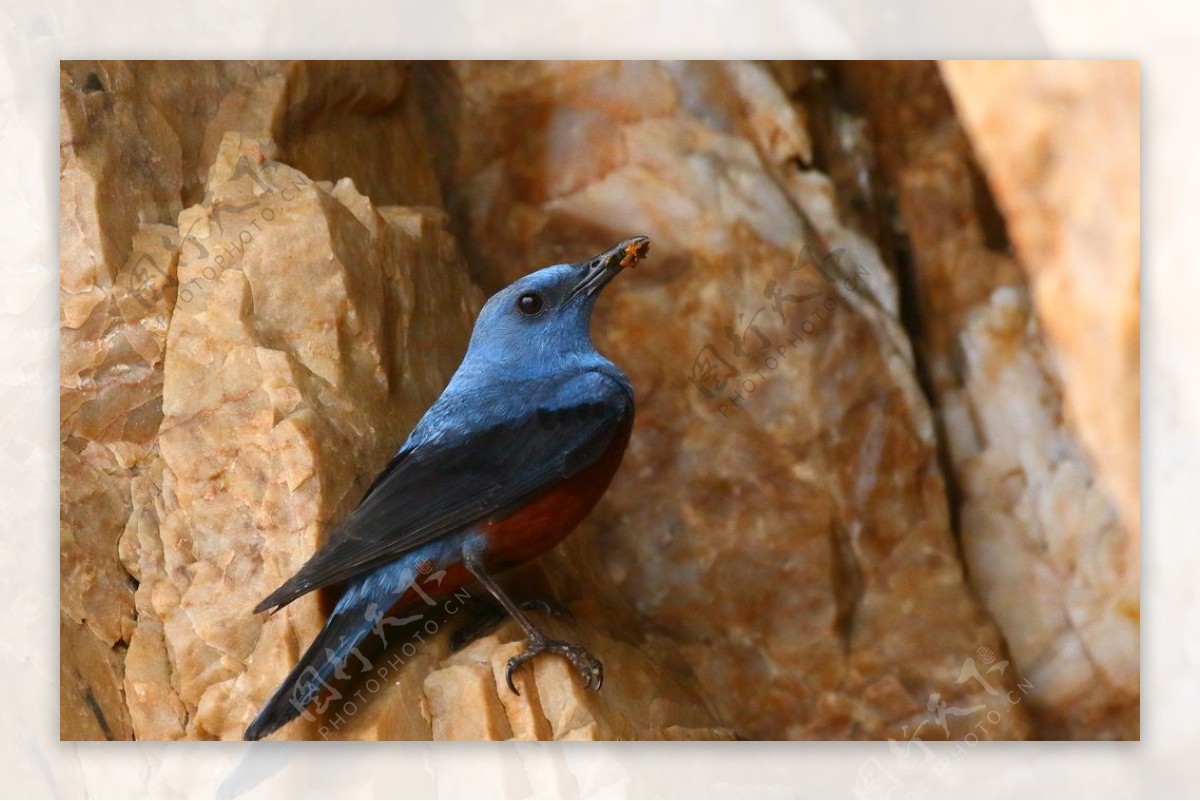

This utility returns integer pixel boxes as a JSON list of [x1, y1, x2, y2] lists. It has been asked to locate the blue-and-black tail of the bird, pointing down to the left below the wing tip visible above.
[[242, 567, 407, 740]]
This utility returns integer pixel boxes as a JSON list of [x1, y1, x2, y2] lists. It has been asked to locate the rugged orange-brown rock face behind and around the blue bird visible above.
[[62, 62, 1138, 742]]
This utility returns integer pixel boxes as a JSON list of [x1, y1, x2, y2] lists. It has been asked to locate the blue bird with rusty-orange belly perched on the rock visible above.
[[244, 236, 650, 740]]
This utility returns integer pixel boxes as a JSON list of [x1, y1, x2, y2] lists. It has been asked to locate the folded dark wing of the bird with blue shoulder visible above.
[[250, 372, 634, 612]]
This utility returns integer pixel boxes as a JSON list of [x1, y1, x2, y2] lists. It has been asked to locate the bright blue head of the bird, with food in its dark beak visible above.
[[463, 236, 650, 372]]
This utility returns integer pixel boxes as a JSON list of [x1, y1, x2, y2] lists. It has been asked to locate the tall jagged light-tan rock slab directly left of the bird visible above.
[[143, 135, 480, 737]]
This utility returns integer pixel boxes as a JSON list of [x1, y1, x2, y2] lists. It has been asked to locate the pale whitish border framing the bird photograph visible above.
[[7, 0, 1200, 797]]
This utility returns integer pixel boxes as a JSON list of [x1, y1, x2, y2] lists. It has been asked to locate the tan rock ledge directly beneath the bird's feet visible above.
[[325, 613, 732, 740]]
